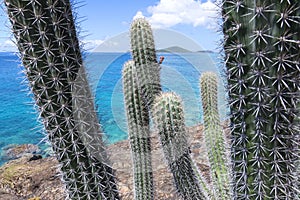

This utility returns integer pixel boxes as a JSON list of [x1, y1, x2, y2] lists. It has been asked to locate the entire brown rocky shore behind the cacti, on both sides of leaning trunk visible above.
[[0, 126, 219, 200]]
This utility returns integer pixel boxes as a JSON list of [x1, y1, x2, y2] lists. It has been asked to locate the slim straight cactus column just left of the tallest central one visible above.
[[122, 61, 154, 200]]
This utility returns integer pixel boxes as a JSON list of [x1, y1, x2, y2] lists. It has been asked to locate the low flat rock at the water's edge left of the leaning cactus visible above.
[[2, 144, 40, 160]]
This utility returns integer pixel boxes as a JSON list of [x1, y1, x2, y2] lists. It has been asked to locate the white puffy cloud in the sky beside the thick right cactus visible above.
[[143, 0, 218, 28]]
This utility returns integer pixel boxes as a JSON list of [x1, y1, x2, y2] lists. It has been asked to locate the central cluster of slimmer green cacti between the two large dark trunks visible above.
[[123, 18, 230, 200]]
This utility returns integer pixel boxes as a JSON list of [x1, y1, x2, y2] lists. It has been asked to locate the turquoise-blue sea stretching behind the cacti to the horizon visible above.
[[0, 52, 227, 165]]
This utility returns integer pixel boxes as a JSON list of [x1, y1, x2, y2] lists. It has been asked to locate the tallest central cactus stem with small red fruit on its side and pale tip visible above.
[[130, 18, 161, 107]]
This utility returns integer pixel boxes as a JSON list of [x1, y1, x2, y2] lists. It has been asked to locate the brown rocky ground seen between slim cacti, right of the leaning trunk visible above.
[[108, 126, 209, 200]]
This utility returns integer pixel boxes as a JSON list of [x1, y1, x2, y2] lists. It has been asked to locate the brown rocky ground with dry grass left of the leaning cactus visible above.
[[0, 155, 65, 200]]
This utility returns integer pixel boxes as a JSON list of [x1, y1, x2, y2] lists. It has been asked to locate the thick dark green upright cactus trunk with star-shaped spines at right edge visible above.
[[222, 0, 300, 199]]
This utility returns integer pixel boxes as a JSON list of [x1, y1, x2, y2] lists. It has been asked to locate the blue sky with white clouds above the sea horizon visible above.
[[0, 0, 220, 51]]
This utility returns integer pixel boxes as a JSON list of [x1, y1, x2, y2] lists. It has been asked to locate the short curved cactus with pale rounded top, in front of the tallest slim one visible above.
[[153, 93, 208, 200]]
